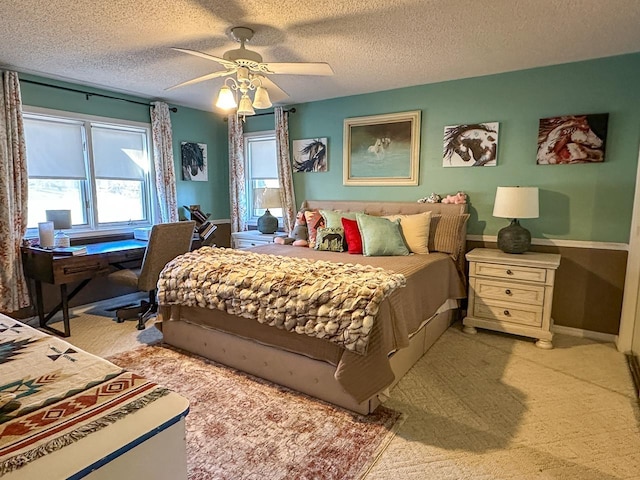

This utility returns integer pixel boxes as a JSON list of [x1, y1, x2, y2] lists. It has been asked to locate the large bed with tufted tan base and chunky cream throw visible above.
[[158, 201, 468, 414]]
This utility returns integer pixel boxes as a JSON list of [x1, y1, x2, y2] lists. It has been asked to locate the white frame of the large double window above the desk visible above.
[[22, 105, 157, 238]]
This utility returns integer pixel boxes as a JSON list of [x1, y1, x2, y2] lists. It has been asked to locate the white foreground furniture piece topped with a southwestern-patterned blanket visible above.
[[0, 314, 189, 480]]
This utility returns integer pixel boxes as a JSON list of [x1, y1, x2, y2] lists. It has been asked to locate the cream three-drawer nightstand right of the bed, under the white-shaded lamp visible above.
[[462, 248, 560, 349]]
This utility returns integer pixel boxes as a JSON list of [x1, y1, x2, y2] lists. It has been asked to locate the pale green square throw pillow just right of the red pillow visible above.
[[356, 213, 410, 257]]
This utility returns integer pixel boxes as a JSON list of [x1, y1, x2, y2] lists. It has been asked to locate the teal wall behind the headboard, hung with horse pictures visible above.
[[245, 54, 640, 243]]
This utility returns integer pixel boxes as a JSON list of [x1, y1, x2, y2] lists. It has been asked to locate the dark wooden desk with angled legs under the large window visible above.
[[22, 239, 147, 337]]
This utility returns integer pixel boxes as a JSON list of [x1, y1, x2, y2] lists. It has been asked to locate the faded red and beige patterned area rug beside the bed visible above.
[[108, 344, 403, 480]]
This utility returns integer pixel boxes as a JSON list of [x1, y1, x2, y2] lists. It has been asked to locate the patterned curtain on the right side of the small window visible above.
[[274, 107, 297, 232]]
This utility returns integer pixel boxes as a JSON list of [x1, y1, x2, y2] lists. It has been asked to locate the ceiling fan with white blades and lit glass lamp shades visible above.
[[167, 27, 333, 116]]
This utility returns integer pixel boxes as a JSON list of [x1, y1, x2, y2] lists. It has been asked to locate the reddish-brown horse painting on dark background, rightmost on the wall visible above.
[[536, 113, 609, 165]]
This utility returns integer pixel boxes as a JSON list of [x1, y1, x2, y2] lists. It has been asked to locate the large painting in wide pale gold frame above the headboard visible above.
[[342, 110, 420, 185]]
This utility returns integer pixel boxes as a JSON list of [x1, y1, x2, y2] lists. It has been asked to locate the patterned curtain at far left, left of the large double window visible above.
[[0, 72, 29, 312]]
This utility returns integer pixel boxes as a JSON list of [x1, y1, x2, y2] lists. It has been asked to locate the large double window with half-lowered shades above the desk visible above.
[[24, 107, 152, 236]]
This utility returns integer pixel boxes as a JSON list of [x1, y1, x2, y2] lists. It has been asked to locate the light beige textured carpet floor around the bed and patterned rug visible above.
[[41, 296, 640, 480]]
